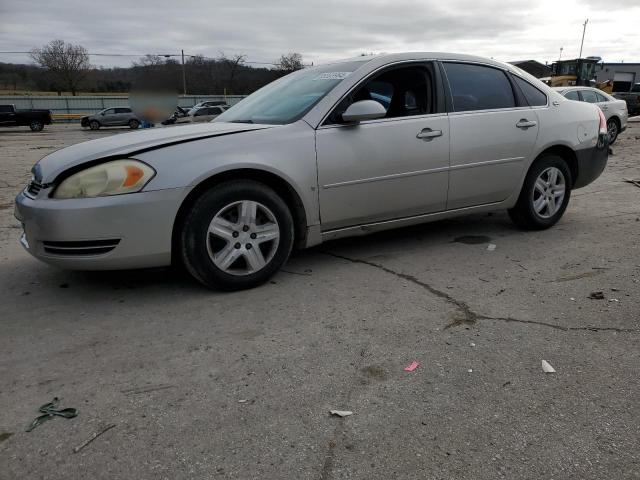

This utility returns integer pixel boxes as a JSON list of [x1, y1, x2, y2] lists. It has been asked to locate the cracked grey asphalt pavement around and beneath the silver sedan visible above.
[[0, 123, 640, 480]]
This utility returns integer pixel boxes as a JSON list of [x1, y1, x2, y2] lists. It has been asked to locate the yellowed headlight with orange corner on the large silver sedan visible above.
[[53, 159, 156, 198]]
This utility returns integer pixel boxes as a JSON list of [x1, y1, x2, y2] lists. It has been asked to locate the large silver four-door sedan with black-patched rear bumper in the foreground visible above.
[[16, 53, 608, 289]]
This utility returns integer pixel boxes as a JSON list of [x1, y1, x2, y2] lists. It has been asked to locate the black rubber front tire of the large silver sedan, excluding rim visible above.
[[180, 180, 294, 291]]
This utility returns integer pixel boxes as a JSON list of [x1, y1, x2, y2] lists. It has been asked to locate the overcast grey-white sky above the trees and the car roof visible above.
[[0, 0, 640, 66]]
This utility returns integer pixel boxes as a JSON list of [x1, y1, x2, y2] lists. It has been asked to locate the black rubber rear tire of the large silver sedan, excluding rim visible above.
[[508, 155, 573, 230]]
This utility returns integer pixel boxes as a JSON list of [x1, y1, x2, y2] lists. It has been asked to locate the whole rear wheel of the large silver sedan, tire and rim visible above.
[[509, 155, 572, 230]]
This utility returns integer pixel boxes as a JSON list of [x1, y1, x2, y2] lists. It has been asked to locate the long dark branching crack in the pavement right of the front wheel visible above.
[[321, 251, 640, 333]]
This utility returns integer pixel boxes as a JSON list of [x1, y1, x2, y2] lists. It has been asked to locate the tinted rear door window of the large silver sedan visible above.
[[444, 63, 516, 112]]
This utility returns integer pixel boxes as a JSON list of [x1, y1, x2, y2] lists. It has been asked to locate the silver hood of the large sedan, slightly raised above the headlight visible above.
[[32, 122, 274, 184]]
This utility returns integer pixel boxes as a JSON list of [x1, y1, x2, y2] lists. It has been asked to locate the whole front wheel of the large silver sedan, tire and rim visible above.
[[181, 180, 294, 290]]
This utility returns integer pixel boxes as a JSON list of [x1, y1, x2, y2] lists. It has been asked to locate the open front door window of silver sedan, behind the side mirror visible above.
[[325, 65, 436, 124]]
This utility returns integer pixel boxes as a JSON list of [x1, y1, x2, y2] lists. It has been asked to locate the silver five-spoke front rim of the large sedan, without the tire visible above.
[[206, 200, 280, 275]]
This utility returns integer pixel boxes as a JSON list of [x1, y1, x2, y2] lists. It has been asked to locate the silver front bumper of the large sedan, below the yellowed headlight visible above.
[[15, 188, 187, 270]]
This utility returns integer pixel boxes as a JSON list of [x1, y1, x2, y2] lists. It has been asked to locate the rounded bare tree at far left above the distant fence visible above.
[[31, 40, 91, 95]]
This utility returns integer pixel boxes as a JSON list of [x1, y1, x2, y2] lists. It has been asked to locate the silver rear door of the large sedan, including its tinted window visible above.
[[443, 62, 546, 210]]
